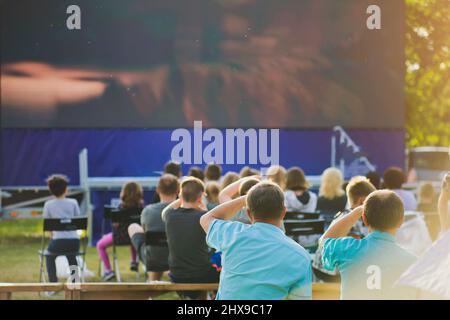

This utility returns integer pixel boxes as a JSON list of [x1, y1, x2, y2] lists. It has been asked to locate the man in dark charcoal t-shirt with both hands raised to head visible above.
[[162, 177, 219, 299]]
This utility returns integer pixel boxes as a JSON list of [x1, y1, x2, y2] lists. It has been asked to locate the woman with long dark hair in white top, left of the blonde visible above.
[[284, 167, 317, 212]]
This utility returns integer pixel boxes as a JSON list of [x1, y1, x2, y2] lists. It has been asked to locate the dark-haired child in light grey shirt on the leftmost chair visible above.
[[43, 175, 80, 282]]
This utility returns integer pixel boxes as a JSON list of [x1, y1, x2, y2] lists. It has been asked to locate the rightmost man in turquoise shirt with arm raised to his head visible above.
[[321, 190, 416, 299]]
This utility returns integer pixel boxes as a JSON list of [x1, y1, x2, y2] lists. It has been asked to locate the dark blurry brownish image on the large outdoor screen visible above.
[[1, 0, 404, 128]]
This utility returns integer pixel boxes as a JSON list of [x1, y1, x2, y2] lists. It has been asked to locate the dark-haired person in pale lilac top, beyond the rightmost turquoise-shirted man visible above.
[[383, 167, 417, 211]]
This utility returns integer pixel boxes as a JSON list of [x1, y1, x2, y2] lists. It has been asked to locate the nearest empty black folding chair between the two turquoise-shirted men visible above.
[[284, 219, 325, 253]]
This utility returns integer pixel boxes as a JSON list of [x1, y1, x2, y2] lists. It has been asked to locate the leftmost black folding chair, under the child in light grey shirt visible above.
[[38, 217, 88, 282]]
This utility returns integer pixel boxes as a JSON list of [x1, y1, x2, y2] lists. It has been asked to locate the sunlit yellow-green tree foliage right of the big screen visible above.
[[405, 0, 450, 147]]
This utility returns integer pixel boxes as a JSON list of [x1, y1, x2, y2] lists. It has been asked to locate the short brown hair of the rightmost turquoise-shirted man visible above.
[[364, 190, 404, 231]]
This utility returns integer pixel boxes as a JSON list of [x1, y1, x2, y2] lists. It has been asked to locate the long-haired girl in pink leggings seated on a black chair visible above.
[[97, 182, 144, 281]]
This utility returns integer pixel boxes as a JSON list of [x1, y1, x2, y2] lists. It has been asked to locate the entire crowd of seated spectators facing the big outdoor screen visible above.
[[44, 162, 450, 299]]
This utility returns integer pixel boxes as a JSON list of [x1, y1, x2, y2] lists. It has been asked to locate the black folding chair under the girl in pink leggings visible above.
[[100, 206, 142, 282]]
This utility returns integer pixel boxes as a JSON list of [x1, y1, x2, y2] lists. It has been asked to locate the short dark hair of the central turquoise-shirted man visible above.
[[246, 182, 284, 220]]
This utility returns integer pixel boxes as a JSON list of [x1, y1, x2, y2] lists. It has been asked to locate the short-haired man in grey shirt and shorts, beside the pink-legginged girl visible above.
[[128, 173, 180, 281]]
